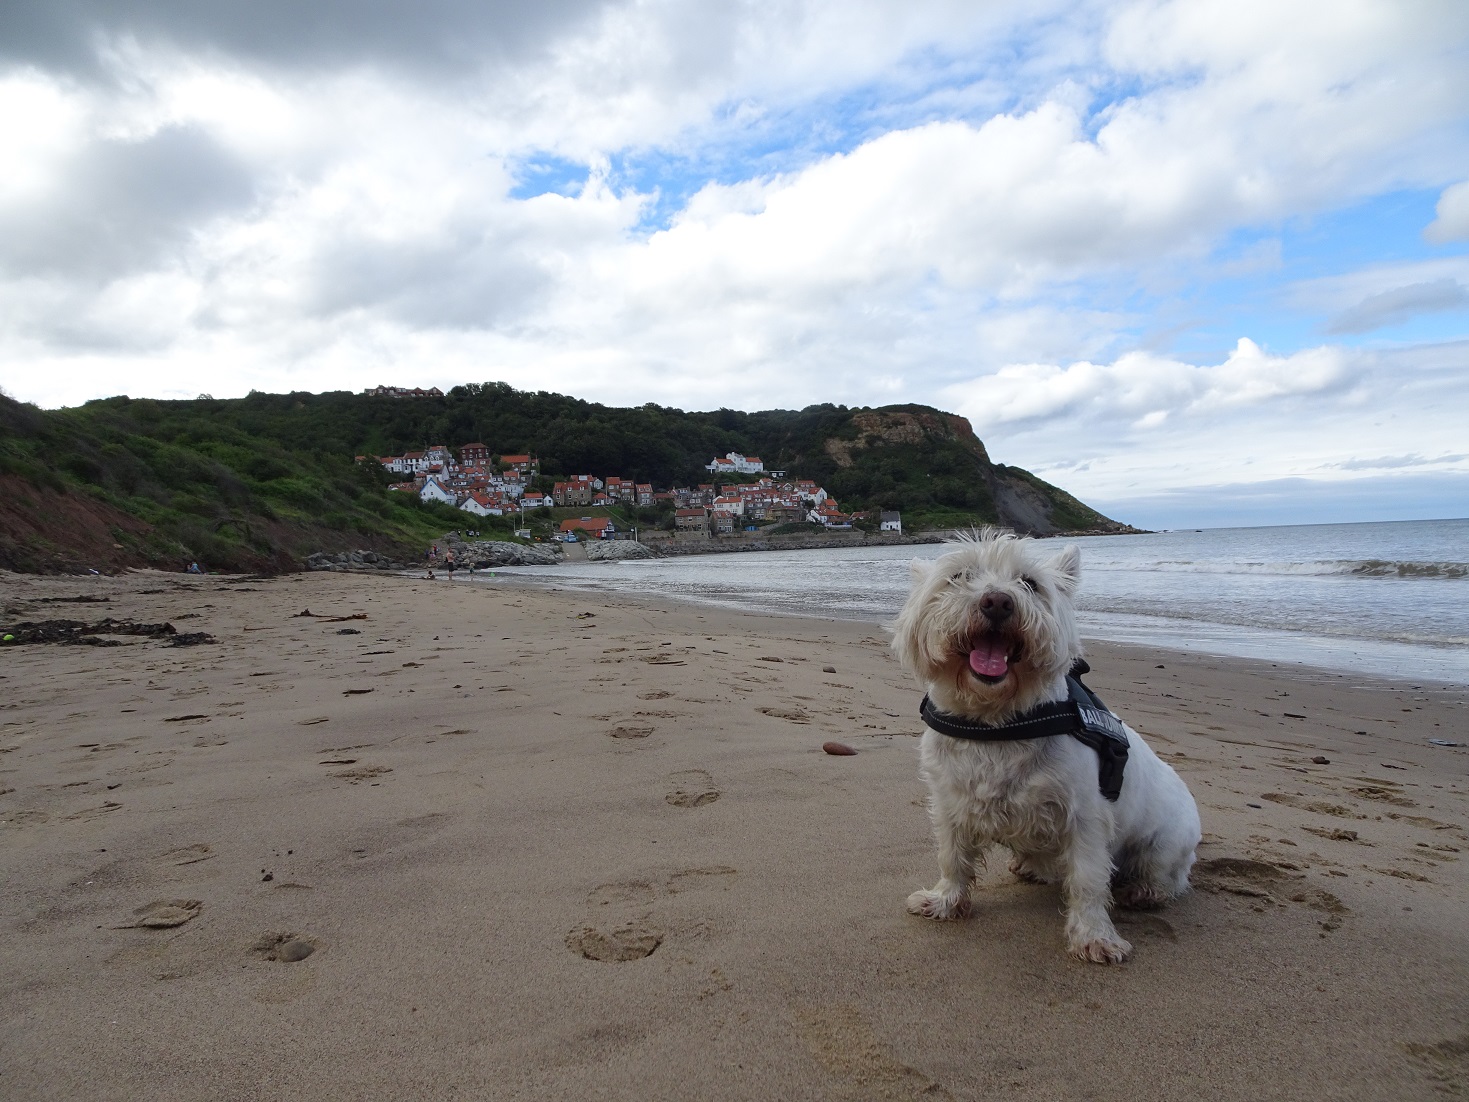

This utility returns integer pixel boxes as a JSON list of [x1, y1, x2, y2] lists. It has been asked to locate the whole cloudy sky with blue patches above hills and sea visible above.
[[0, 0, 1469, 526]]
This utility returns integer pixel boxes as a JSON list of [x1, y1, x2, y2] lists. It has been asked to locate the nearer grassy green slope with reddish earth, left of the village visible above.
[[0, 397, 485, 572]]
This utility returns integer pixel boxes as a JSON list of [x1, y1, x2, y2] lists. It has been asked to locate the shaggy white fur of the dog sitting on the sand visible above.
[[890, 530, 1200, 964]]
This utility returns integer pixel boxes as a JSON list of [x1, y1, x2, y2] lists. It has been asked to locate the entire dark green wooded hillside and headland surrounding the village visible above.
[[0, 383, 1122, 570]]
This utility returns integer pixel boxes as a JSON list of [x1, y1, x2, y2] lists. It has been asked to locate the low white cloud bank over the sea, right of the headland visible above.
[[943, 341, 1469, 505]]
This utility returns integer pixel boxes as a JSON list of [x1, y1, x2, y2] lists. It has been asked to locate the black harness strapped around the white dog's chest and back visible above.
[[918, 658, 1127, 802]]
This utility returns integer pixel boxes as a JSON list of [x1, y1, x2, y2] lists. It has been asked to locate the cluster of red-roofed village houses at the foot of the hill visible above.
[[367, 441, 902, 542]]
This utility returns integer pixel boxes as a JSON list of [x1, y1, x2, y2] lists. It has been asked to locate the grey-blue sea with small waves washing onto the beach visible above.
[[479, 519, 1469, 683]]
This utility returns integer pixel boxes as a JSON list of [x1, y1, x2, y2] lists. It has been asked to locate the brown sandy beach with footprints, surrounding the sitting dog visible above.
[[0, 573, 1469, 1102]]
